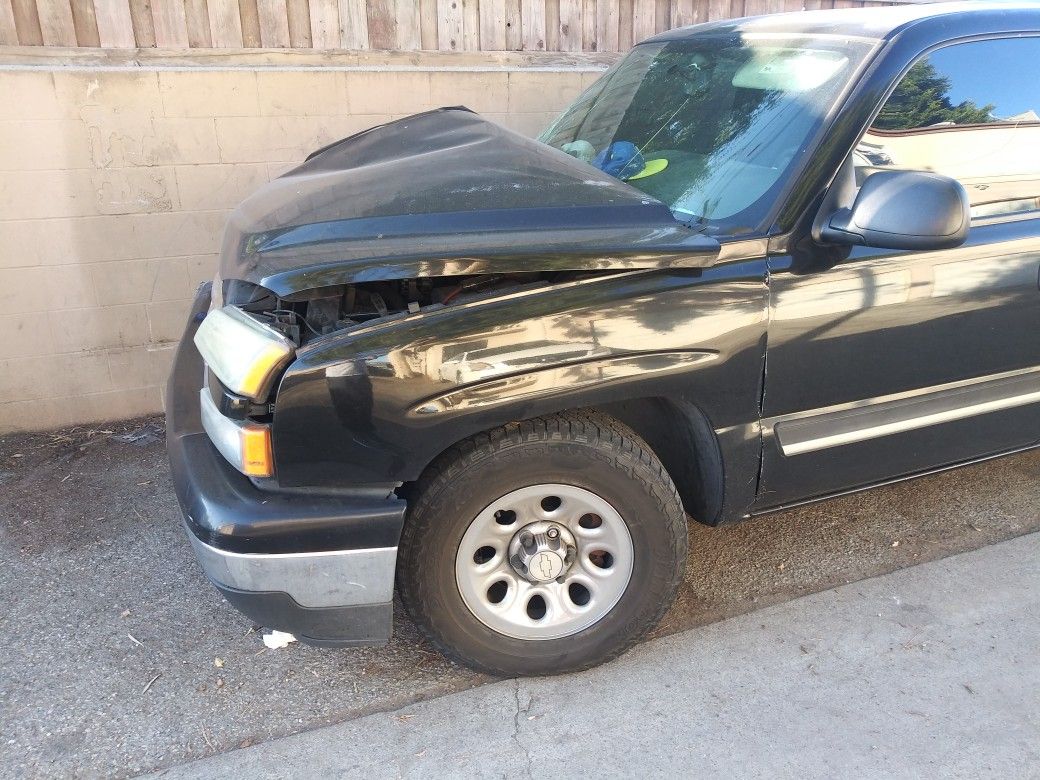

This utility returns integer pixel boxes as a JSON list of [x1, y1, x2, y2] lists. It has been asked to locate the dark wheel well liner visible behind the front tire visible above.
[[597, 397, 724, 525]]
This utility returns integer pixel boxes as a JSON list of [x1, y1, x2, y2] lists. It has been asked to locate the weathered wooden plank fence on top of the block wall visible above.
[[0, 0, 894, 52]]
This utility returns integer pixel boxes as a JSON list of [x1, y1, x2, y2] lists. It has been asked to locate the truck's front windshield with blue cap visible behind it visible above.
[[541, 33, 874, 234]]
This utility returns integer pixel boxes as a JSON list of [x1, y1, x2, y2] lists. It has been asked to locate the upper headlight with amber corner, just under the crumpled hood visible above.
[[194, 306, 295, 402]]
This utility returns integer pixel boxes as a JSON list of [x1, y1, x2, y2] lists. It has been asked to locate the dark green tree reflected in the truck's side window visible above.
[[874, 59, 994, 130]]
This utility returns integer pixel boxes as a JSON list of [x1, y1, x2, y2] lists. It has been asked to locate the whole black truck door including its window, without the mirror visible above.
[[758, 37, 1040, 509]]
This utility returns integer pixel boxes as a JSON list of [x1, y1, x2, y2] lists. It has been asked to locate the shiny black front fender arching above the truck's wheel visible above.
[[274, 259, 766, 520]]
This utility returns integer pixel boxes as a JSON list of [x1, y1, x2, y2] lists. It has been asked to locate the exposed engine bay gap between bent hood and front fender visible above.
[[224, 271, 618, 346]]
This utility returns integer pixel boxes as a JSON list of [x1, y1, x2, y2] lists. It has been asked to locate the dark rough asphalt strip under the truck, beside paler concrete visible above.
[[0, 419, 1040, 777]]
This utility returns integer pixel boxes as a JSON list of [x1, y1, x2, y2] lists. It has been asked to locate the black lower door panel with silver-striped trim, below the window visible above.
[[759, 219, 1040, 506]]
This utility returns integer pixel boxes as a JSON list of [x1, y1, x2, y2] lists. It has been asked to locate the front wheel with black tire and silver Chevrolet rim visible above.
[[397, 412, 686, 676]]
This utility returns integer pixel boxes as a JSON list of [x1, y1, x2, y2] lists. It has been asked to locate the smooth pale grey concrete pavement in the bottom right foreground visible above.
[[151, 534, 1040, 780]]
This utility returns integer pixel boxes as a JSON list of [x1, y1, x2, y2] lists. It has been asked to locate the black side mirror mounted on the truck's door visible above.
[[820, 171, 971, 250]]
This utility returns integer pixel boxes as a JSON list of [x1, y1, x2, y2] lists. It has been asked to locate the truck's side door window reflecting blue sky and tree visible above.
[[855, 37, 1040, 217]]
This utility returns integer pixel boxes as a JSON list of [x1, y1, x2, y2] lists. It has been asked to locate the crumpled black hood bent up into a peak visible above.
[[220, 108, 719, 296]]
